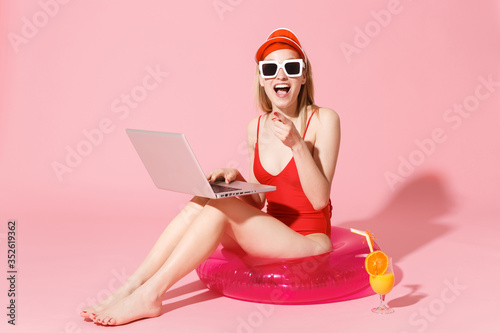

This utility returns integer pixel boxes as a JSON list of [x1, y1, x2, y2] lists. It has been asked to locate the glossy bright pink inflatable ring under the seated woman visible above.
[[196, 226, 379, 304]]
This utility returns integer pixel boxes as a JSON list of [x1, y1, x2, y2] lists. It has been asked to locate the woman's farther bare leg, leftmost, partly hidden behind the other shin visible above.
[[80, 197, 208, 319]]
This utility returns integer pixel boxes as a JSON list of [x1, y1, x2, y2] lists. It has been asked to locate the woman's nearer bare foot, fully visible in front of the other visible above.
[[93, 288, 161, 325]]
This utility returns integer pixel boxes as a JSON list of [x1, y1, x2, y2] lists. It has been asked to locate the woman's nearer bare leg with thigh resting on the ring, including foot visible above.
[[94, 198, 331, 325]]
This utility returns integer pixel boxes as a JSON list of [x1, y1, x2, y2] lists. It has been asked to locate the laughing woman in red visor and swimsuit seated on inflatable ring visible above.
[[81, 29, 340, 325]]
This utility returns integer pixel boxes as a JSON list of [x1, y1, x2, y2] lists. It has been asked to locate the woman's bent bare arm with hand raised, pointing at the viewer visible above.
[[274, 108, 340, 210]]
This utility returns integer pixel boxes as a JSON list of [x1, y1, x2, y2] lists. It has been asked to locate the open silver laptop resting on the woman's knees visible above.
[[126, 129, 276, 199]]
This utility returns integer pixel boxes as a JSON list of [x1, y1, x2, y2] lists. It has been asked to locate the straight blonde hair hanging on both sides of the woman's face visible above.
[[255, 59, 318, 135]]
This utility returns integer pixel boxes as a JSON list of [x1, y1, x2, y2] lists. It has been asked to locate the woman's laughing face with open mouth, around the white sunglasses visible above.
[[259, 49, 306, 114]]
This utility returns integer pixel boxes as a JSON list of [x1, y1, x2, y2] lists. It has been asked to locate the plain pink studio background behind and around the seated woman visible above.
[[0, 0, 500, 332]]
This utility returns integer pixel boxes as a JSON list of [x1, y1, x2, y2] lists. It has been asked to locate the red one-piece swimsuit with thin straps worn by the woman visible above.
[[253, 112, 332, 236]]
